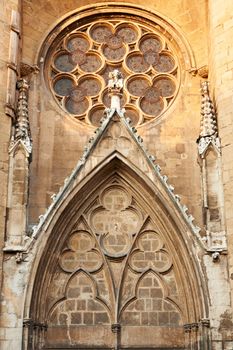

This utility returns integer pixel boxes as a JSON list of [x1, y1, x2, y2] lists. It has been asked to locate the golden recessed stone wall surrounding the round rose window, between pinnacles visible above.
[[22, 0, 207, 225]]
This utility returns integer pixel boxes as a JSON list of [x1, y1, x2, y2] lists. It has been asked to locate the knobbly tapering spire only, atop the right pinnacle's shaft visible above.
[[197, 81, 220, 156]]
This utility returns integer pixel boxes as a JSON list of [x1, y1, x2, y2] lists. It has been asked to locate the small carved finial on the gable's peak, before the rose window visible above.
[[108, 69, 124, 110]]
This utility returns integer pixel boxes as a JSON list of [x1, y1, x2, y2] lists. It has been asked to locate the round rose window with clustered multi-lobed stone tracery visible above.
[[49, 19, 179, 126]]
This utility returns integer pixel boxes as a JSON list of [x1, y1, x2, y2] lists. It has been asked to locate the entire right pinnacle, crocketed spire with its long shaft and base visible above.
[[197, 81, 226, 262]]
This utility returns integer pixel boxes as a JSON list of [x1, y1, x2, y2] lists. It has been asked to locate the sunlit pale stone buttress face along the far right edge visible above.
[[209, 0, 233, 318]]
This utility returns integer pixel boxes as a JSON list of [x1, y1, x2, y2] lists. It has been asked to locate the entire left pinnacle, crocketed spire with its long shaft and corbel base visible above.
[[4, 79, 32, 249]]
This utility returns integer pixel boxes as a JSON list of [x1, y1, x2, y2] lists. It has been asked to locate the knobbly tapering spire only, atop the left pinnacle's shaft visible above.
[[10, 78, 32, 154]]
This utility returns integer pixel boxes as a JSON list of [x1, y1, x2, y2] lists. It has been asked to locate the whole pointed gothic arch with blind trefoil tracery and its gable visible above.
[[25, 111, 208, 349]]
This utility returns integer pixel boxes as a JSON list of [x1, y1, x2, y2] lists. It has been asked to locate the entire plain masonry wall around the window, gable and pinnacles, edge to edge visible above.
[[0, 0, 233, 350]]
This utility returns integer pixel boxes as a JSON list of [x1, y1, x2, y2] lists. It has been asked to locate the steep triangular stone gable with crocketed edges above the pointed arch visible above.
[[28, 107, 204, 252]]
